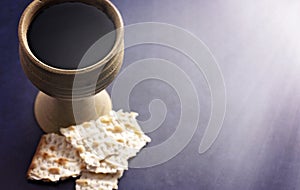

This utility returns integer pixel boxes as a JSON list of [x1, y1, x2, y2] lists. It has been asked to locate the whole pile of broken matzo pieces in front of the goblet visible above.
[[28, 110, 151, 190]]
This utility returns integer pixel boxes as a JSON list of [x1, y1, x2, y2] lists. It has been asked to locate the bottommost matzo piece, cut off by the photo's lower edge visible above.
[[76, 171, 123, 190]]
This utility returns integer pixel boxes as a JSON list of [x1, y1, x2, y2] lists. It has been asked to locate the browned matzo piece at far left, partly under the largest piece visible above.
[[27, 133, 85, 182]]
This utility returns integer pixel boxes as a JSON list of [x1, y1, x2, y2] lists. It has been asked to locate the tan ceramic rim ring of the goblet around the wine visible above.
[[18, 0, 124, 75]]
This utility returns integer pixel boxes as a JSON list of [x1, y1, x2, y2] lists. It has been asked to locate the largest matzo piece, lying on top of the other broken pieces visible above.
[[61, 111, 150, 173]]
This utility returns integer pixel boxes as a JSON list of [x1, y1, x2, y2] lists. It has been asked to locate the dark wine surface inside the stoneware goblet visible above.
[[27, 2, 115, 69]]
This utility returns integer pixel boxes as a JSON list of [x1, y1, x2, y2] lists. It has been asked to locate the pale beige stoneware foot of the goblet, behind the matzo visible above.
[[34, 90, 112, 133]]
